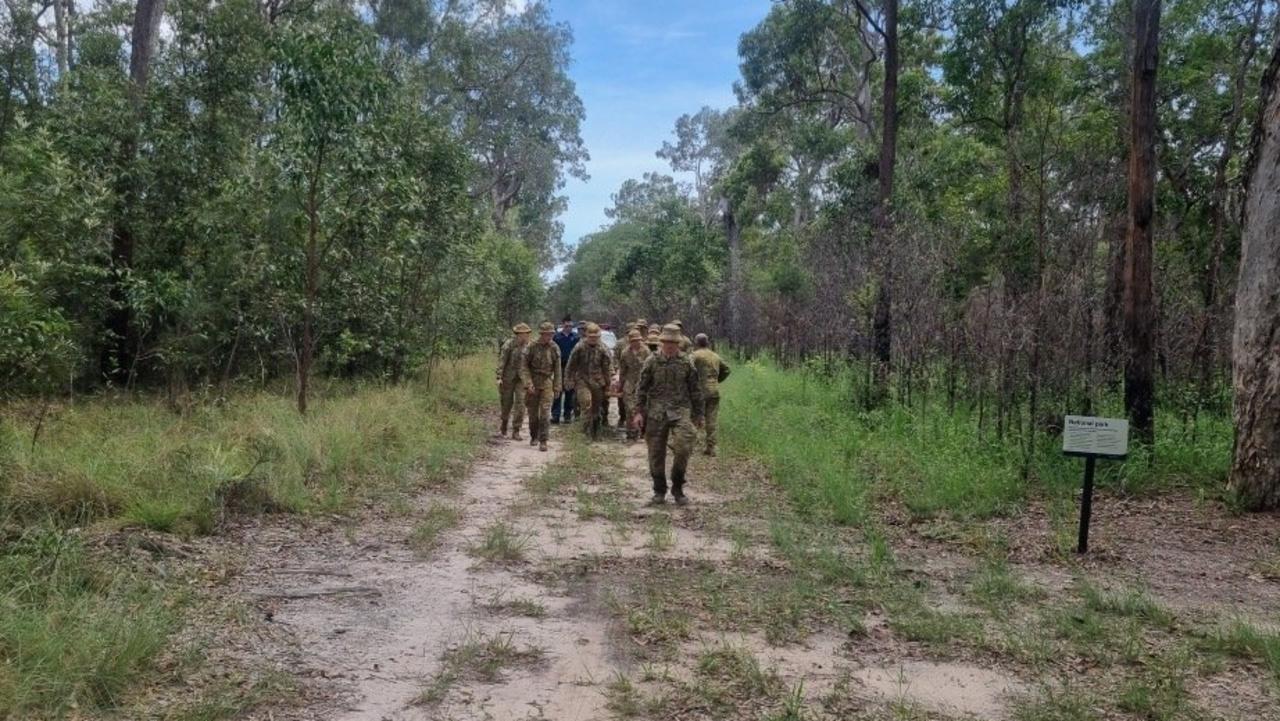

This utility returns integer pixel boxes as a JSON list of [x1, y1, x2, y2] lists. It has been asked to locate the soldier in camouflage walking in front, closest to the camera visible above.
[[632, 323, 703, 506]]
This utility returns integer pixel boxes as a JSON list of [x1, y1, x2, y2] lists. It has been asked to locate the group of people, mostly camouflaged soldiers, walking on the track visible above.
[[498, 318, 730, 506]]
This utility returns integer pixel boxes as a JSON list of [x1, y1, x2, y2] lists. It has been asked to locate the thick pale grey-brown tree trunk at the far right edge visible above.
[[1230, 41, 1280, 510]]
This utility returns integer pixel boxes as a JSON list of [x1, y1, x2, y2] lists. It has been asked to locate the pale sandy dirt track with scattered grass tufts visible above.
[[225, 417, 1039, 721]]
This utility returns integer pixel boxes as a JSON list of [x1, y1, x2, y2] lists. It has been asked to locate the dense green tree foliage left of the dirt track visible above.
[[0, 0, 585, 393]]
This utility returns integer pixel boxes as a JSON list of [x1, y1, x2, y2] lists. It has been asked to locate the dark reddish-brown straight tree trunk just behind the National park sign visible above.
[[1124, 0, 1160, 447]]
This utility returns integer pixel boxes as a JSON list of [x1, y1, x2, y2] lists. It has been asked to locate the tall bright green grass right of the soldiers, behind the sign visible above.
[[721, 359, 1231, 525]]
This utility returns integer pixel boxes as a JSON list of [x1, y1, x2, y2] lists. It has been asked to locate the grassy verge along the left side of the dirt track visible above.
[[0, 359, 492, 718]]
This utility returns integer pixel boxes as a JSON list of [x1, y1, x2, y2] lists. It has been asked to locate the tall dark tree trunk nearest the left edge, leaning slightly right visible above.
[[100, 0, 165, 384]]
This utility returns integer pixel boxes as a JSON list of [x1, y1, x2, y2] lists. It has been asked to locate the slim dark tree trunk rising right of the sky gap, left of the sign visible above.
[[872, 0, 897, 398]]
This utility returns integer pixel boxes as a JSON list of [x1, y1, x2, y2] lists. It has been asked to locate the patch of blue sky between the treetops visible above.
[[550, 0, 771, 258]]
